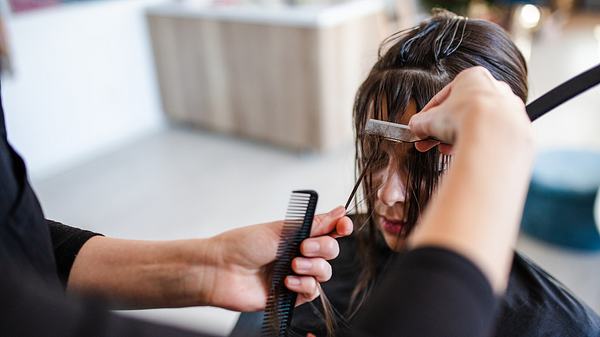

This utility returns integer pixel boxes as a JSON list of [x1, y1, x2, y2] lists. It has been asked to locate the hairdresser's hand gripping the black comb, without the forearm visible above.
[[204, 207, 352, 311]]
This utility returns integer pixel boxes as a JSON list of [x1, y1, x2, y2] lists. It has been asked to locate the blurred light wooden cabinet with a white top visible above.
[[147, 0, 385, 150]]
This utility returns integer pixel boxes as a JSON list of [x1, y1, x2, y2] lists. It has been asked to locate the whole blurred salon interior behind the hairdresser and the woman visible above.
[[0, 0, 600, 334]]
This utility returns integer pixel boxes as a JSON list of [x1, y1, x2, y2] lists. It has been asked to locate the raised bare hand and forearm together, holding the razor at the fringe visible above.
[[409, 67, 534, 294]]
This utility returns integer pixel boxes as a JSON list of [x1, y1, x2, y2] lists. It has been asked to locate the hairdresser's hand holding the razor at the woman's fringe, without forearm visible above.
[[409, 67, 529, 154]]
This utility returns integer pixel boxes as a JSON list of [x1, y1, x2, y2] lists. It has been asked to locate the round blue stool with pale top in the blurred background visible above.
[[521, 151, 600, 250]]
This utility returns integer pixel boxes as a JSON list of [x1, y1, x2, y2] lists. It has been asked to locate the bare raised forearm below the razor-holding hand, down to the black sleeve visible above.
[[412, 113, 533, 292]]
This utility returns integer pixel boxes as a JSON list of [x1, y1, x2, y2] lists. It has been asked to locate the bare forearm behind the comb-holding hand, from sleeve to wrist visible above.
[[68, 237, 215, 308]]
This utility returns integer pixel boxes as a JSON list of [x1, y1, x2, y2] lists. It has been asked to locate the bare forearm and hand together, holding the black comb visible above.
[[68, 211, 346, 311]]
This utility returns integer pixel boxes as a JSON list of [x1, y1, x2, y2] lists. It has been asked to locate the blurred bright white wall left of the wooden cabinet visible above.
[[2, 0, 169, 179]]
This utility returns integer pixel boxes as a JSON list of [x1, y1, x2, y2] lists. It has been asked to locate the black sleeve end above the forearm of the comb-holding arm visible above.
[[46, 220, 100, 287]]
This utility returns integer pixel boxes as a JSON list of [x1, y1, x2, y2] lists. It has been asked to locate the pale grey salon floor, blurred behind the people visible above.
[[34, 11, 600, 334]]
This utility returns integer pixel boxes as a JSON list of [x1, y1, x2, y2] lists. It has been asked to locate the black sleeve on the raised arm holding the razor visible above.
[[345, 247, 497, 337]]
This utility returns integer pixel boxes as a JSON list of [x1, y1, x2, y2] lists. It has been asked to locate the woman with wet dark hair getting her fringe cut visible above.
[[292, 10, 600, 337]]
